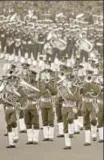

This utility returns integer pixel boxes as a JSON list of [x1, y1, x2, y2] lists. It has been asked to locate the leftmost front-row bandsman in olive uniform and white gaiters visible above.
[[2, 76, 18, 148]]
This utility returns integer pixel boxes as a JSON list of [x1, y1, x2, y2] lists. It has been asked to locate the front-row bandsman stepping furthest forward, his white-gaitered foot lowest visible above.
[[58, 73, 80, 149]]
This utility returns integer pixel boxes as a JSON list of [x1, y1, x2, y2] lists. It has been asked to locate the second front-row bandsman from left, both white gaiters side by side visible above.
[[24, 71, 39, 144]]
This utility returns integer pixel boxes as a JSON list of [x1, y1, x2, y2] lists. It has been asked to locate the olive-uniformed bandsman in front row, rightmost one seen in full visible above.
[[82, 72, 100, 146]]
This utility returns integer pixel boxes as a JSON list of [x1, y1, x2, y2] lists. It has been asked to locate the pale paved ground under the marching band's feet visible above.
[[0, 61, 103, 160]]
